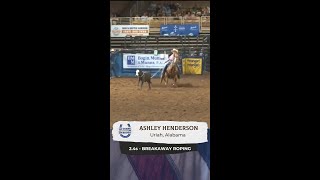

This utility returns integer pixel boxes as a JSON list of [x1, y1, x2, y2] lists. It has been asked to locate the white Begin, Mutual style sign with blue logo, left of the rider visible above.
[[123, 53, 169, 69]]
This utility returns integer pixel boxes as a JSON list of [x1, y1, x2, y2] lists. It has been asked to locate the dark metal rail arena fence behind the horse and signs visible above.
[[111, 36, 211, 73]]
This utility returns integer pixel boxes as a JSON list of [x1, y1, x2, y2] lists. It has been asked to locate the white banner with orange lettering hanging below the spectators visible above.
[[110, 25, 149, 37]]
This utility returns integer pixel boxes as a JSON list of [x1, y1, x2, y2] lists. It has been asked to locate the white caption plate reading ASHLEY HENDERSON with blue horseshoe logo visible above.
[[112, 121, 208, 145]]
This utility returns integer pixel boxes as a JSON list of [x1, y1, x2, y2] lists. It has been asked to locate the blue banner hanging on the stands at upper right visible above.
[[160, 24, 200, 36]]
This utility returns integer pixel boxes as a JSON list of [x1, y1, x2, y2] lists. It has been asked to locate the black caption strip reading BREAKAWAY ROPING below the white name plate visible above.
[[119, 142, 197, 155]]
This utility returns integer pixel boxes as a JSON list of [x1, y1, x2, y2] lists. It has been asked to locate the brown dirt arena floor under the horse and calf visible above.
[[110, 73, 210, 127]]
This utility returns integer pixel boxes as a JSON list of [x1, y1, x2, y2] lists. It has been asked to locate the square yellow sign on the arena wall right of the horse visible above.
[[182, 58, 202, 74]]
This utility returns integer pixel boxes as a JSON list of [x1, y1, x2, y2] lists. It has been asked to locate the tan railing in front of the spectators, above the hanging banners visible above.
[[110, 16, 210, 32]]
